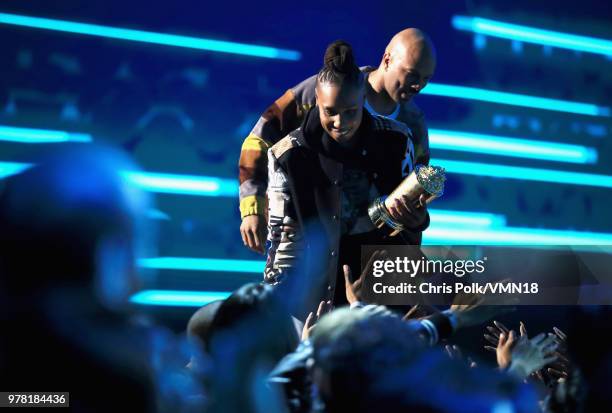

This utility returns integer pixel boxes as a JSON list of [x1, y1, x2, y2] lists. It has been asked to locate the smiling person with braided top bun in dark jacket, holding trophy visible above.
[[264, 40, 429, 305]]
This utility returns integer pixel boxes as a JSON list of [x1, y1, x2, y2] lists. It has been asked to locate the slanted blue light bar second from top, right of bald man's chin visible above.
[[421, 83, 610, 116]]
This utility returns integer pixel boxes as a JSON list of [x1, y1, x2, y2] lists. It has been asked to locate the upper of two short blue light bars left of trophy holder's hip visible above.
[[139, 257, 265, 274]]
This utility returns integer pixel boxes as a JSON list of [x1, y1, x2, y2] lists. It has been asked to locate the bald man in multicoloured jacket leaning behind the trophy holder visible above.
[[238, 28, 436, 254]]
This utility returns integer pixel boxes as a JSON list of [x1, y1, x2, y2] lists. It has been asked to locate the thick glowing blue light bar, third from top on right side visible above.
[[429, 129, 597, 164]]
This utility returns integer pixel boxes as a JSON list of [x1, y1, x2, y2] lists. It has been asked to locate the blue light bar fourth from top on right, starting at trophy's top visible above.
[[433, 159, 612, 188]]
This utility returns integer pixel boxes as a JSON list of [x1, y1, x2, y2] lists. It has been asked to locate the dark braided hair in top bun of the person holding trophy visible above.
[[317, 40, 363, 85]]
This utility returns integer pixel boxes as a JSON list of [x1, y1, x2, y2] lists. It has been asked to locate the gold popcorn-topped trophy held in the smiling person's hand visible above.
[[368, 165, 446, 236]]
